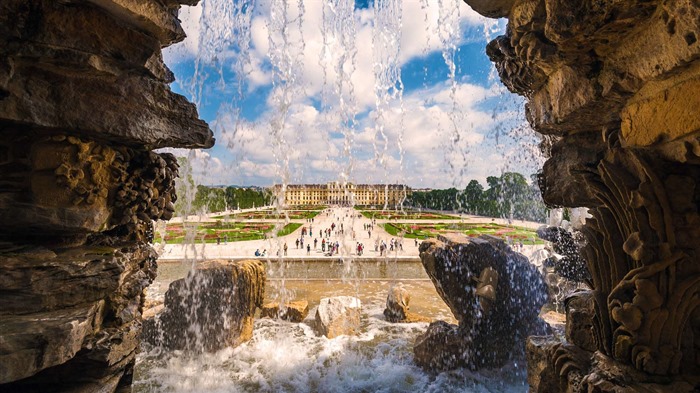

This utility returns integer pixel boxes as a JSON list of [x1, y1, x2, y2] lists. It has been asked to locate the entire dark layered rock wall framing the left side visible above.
[[0, 0, 214, 391]]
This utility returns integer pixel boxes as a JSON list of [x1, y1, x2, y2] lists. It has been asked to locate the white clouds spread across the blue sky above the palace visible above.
[[161, 0, 538, 187]]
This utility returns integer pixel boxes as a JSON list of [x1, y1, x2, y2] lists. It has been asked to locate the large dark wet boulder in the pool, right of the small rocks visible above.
[[414, 235, 547, 370]]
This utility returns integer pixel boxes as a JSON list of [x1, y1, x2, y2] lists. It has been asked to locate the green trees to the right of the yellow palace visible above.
[[405, 172, 547, 222]]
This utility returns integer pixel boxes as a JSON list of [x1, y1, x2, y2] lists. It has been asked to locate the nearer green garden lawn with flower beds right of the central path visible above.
[[384, 222, 544, 244]]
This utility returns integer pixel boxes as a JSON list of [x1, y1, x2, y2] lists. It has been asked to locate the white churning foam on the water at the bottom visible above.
[[134, 297, 527, 392]]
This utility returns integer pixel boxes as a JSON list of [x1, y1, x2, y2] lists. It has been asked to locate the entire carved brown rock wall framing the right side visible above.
[[465, 0, 700, 391]]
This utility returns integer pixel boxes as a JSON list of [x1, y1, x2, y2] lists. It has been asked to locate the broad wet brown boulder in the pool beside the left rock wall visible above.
[[143, 260, 265, 352]]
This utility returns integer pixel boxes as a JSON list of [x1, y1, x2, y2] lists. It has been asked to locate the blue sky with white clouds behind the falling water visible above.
[[164, 0, 541, 188]]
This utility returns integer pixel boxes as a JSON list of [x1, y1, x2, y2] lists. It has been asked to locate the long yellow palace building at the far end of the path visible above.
[[273, 182, 412, 206]]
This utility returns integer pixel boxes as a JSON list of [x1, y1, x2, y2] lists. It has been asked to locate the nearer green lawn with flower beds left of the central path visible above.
[[154, 222, 301, 244]]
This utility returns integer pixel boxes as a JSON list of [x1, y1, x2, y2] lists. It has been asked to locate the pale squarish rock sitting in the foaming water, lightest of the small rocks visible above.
[[315, 296, 361, 338]]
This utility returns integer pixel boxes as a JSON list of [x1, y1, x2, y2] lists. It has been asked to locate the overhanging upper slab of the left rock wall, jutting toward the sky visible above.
[[0, 0, 214, 149]]
